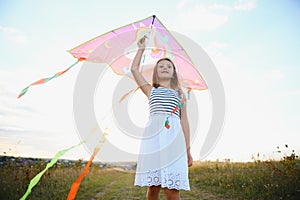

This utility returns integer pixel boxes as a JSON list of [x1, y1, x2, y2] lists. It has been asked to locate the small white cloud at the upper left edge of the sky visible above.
[[0, 25, 29, 45]]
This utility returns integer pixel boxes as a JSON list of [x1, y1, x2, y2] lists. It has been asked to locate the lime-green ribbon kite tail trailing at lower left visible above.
[[20, 142, 84, 200]]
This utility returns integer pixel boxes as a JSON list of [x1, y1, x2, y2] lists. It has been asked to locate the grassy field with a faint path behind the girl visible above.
[[0, 153, 300, 200]]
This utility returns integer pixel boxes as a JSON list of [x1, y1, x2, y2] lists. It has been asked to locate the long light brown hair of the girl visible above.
[[152, 58, 183, 97]]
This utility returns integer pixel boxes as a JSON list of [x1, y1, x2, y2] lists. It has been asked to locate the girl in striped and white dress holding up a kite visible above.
[[131, 37, 193, 200]]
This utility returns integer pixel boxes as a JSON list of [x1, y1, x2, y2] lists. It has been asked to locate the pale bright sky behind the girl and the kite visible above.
[[0, 0, 300, 161]]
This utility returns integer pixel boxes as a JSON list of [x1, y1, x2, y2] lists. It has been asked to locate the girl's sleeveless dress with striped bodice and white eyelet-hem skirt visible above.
[[134, 87, 190, 190]]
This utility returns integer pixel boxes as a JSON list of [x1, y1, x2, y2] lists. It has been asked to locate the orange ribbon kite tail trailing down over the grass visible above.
[[67, 133, 107, 200]]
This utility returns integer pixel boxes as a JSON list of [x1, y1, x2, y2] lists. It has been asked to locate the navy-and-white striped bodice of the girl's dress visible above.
[[149, 87, 180, 117]]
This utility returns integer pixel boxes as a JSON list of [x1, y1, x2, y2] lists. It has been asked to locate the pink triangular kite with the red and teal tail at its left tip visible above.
[[18, 15, 207, 98]]
